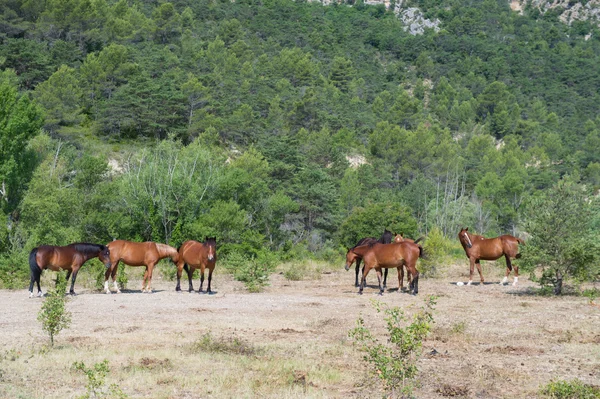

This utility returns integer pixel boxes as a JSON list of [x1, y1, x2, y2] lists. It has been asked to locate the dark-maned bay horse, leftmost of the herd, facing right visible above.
[[29, 243, 110, 298]]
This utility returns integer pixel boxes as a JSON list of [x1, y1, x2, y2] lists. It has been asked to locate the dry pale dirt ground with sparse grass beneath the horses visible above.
[[0, 264, 600, 398]]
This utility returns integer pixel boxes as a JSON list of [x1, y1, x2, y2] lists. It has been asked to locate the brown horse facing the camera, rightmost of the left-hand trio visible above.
[[175, 237, 217, 294]]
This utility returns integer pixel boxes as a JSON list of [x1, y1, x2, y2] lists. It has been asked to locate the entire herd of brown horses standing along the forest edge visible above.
[[29, 228, 524, 297]]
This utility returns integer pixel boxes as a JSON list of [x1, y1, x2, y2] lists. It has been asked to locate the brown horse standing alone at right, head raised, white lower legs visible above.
[[458, 227, 525, 285]]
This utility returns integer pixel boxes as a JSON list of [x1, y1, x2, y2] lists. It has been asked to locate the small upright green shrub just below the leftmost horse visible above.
[[37, 272, 71, 346]]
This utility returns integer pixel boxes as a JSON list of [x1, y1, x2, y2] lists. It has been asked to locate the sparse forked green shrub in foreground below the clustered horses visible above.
[[349, 296, 435, 397]]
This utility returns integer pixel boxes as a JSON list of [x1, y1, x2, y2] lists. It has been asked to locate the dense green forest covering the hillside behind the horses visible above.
[[0, 0, 600, 288]]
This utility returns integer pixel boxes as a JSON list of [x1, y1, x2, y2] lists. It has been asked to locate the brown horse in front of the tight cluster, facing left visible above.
[[346, 242, 419, 295]]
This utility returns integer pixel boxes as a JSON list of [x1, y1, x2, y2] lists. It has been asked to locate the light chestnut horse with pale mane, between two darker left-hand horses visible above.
[[104, 240, 179, 294]]
